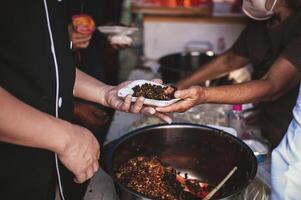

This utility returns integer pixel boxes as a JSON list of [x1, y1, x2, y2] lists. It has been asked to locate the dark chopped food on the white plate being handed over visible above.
[[133, 83, 177, 101]]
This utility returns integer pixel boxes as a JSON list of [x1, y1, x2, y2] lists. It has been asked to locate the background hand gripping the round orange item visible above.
[[68, 24, 92, 50]]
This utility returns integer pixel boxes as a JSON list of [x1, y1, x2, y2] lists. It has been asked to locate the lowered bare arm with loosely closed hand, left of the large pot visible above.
[[0, 87, 100, 182]]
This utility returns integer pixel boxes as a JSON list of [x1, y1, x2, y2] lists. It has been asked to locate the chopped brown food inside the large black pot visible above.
[[115, 156, 213, 200]]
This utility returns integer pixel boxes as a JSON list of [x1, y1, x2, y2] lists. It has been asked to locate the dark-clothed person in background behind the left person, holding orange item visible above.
[[67, 0, 128, 140]]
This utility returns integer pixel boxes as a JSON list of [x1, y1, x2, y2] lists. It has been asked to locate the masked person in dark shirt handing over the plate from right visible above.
[[158, 0, 301, 146]]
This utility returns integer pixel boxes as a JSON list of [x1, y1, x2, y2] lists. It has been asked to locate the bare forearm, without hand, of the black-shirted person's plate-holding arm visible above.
[[74, 69, 112, 106]]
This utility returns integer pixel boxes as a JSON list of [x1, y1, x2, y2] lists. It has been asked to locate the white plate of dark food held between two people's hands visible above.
[[118, 80, 180, 107]]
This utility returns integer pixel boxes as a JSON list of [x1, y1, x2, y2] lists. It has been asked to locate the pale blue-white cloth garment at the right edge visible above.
[[271, 85, 301, 200]]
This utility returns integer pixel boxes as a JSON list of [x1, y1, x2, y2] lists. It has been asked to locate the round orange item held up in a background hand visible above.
[[72, 14, 95, 34]]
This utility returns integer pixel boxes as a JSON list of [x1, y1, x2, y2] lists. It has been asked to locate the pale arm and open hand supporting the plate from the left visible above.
[[74, 69, 171, 123]]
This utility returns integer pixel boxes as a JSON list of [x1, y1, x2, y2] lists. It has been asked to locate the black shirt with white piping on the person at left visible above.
[[0, 0, 75, 200]]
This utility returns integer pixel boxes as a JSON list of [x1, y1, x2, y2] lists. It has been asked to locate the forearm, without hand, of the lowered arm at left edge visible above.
[[0, 87, 68, 152]]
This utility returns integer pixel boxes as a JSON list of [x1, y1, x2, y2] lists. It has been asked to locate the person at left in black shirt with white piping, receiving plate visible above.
[[0, 0, 168, 200]]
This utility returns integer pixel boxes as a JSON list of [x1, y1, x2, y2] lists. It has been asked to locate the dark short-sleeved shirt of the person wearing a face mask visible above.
[[232, 13, 301, 145]]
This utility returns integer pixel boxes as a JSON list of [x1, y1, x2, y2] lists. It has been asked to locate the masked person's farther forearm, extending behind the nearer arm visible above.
[[177, 51, 249, 89]]
